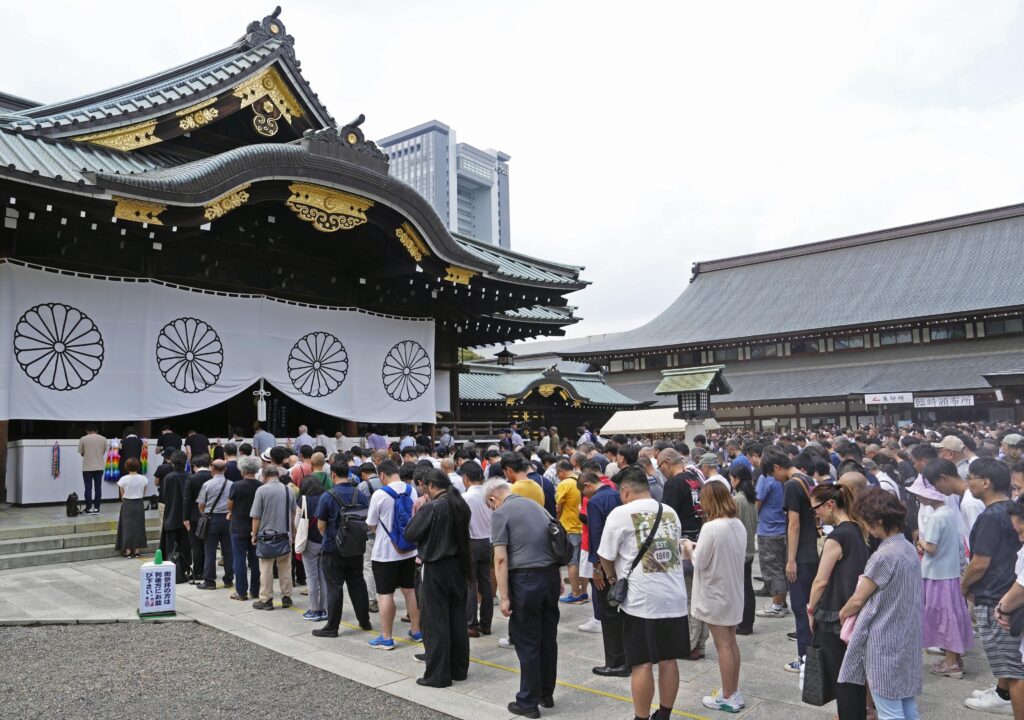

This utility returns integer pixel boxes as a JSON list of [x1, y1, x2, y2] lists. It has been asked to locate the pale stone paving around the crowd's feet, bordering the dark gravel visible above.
[[0, 559, 990, 720]]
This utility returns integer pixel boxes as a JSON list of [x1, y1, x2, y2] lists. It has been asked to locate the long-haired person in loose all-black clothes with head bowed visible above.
[[406, 468, 470, 687]]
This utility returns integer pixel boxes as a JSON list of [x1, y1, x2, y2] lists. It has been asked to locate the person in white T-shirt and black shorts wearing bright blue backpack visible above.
[[367, 460, 423, 650]]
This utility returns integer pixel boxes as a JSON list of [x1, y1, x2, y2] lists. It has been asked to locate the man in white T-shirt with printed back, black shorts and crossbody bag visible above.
[[597, 465, 690, 718]]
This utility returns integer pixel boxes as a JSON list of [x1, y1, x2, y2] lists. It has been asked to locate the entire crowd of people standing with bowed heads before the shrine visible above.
[[90, 423, 1024, 720]]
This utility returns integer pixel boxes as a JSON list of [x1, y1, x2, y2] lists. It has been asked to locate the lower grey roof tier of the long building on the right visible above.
[[607, 337, 1024, 406]]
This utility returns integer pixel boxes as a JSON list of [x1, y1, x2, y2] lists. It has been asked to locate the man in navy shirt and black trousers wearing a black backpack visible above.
[[312, 462, 373, 637]]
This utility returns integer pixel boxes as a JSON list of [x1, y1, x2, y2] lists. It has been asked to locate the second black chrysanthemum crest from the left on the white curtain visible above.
[[157, 317, 224, 392]]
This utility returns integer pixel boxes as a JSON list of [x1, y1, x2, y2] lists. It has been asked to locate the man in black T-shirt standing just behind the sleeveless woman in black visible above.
[[761, 448, 818, 673]]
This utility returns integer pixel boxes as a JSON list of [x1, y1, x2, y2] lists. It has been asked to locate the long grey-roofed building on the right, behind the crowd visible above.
[[565, 205, 1024, 429]]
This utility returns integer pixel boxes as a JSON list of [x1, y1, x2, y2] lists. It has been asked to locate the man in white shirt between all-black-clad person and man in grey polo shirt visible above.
[[460, 463, 495, 637]]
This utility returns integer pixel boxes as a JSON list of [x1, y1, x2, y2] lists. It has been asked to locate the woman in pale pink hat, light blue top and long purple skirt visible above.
[[908, 472, 974, 679]]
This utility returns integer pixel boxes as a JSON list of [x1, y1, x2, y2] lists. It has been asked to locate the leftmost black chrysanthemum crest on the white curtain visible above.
[[14, 302, 103, 390]]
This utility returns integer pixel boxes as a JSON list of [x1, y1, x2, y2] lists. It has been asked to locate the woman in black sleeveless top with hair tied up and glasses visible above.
[[806, 484, 870, 720]]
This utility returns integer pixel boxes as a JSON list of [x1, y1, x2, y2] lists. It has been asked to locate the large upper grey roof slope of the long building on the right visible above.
[[564, 206, 1024, 356]]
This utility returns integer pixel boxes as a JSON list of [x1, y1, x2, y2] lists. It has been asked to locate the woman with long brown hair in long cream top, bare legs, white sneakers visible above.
[[683, 482, 746, 713]]
